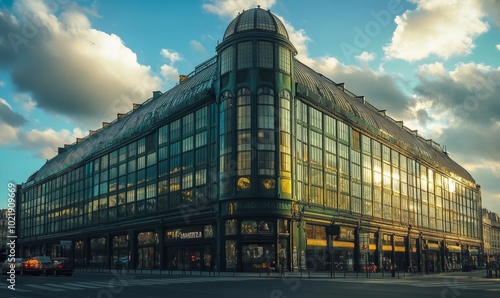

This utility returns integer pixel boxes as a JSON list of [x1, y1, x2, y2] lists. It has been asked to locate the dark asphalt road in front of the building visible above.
[[0, 272, 500, 298]]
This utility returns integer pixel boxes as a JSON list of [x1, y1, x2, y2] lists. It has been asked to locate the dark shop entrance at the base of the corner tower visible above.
[[241, 243, 276, 272]]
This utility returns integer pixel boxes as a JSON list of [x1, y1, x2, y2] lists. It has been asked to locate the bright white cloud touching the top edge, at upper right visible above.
[[384, 0, 488, 61]]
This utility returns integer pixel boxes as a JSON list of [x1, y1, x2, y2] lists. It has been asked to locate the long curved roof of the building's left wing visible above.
[[27, 59, 216, 183]]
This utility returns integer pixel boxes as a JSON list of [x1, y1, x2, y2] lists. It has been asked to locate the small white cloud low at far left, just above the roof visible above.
[[19, 128, 86, 159]]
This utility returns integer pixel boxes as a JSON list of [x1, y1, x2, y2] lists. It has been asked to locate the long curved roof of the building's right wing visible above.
[[294, 60, 475, 183]]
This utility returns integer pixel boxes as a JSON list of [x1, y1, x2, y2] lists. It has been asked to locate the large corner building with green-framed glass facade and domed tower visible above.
[[18, 8, 482, 272]]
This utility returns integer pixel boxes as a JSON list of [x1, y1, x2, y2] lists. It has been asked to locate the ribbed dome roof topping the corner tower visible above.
[[223, 7, 289, 40]]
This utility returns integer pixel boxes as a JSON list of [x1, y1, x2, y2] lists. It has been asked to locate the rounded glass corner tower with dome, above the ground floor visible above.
[[216, 7, 297, 199]]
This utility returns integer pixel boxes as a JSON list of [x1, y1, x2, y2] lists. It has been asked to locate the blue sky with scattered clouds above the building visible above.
[[0, 0, 500, 213]]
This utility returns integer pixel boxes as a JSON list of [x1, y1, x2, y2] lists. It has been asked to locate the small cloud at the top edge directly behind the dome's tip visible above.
[[203, 0, 276, 19]]
